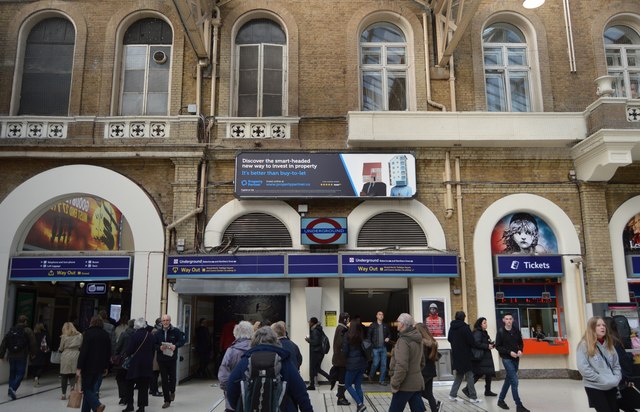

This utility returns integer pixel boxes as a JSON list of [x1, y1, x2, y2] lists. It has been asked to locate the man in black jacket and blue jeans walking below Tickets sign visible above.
[[496, 312, 529, 412]]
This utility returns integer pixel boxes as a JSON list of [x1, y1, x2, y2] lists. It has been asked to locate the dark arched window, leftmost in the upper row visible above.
[[18, 17, 76, 116]]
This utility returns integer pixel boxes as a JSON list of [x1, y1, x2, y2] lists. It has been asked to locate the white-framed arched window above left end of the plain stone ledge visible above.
[[360, 22, 408, 111]]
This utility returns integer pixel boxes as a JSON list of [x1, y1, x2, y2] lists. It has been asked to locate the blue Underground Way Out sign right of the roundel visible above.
[[342, 254, 458, 277]]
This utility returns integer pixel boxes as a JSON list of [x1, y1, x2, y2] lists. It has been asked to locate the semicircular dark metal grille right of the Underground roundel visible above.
[[358, 212, 427, 247]]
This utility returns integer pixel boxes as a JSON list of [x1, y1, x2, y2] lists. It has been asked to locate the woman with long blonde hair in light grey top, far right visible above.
[[576, 316, 622, 412]]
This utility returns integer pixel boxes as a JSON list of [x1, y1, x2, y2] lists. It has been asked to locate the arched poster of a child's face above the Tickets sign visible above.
[[491, 212, 558, 255]]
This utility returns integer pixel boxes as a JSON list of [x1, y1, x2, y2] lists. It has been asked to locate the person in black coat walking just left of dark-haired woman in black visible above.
[[447, 311, 481, 403]]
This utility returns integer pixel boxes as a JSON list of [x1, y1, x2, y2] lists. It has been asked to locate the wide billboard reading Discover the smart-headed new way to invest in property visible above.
[[235, 151, 416, 199]]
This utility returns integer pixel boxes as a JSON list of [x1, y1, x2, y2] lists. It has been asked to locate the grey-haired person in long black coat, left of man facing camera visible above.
[[123, 318, 154, 412]]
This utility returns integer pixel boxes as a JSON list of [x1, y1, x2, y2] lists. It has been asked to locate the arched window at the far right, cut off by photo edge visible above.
[[604, 25, 640, 99]]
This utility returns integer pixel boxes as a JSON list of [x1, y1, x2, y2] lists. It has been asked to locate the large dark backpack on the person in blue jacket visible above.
[[236, 351, 287, 412]]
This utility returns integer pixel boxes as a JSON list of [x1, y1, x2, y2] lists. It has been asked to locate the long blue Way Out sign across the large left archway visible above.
[[9, 256, 131, 282]]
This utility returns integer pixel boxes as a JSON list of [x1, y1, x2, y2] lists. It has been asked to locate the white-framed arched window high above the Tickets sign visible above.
[[482, 23, 531, 112]]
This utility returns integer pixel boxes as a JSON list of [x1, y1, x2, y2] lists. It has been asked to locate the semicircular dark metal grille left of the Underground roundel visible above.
[[222, 213, 292, 247]]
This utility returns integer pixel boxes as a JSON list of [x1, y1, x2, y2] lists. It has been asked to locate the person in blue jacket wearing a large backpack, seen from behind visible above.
[[227, 326, 313, 412]]
